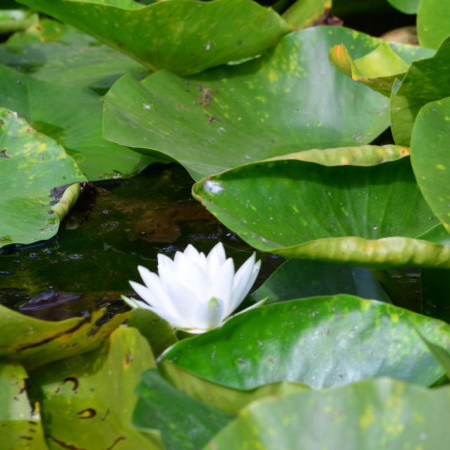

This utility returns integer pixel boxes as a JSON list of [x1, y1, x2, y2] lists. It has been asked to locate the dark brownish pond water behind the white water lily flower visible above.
[[0, 165, 281, 320]]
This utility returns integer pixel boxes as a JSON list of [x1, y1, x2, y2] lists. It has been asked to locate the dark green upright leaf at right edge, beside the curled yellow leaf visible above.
[[391, 38, 450, 145]]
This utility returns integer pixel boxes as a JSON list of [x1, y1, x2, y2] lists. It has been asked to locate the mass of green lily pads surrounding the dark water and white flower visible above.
[[0, 0, 450, 450]]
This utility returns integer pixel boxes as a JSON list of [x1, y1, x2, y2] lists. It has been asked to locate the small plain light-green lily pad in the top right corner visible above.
[[417, 0, 450, 48]]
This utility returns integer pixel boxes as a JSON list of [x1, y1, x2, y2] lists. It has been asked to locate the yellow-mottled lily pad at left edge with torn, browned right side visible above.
[[0, 107, 86, 247]]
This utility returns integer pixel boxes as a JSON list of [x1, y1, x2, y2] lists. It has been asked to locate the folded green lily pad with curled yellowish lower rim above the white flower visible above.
[[193, 158, 450, 268]]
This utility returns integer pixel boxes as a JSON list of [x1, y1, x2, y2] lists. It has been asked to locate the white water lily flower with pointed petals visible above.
[[122, 242, 261, 333]]
